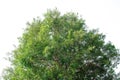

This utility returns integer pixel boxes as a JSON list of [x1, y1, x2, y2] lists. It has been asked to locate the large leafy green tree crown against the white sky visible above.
[[3, 9, 119, 80]]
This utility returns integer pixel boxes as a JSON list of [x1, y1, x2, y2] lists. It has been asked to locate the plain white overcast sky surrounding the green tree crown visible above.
[[0, 0, 120, 78]]
